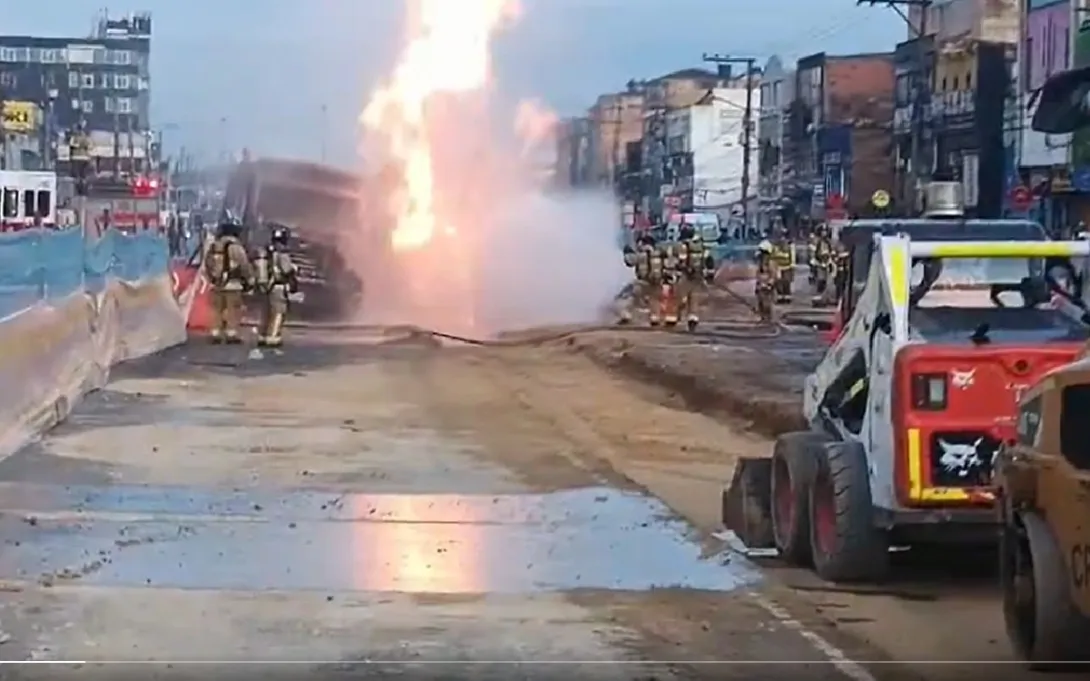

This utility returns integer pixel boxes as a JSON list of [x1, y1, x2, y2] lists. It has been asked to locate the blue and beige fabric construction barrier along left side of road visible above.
[[0, 228, 192, 457]]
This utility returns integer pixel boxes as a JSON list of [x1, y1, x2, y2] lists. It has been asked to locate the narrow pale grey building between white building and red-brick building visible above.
[[756, 57, 795, 230]]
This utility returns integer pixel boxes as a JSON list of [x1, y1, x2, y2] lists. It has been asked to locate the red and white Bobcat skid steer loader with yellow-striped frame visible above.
[[724, 219, 1090, 582]]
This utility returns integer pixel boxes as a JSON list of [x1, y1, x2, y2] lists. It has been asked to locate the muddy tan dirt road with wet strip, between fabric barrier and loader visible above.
[[0, 335, 908, 681]]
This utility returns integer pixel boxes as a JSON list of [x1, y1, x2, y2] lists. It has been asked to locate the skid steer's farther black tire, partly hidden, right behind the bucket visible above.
[[770, 431, 829, 568]]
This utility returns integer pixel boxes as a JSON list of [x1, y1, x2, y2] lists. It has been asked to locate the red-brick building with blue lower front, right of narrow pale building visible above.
[[784, 52, 894, 227]]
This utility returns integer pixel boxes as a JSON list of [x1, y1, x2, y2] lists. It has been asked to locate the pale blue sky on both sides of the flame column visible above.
[[8, 0, 907, 167]]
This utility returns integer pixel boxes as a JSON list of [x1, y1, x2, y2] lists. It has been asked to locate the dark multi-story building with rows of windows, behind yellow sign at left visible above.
[[0, 14, 154, 172]]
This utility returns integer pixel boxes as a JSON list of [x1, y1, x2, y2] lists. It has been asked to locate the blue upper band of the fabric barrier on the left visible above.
[[0, 228, 170, 319]]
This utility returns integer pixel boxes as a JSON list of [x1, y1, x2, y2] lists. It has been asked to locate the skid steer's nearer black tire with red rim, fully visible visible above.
[[808, 442, 889, 582]]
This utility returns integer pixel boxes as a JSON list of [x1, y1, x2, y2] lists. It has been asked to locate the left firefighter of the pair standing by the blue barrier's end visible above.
[[204, 218, 254, 344]]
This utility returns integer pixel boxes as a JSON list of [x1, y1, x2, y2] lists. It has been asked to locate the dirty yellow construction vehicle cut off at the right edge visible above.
[[995, 358, 1090, 670]]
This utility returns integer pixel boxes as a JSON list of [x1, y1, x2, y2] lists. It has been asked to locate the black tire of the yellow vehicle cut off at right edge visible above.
[[1000, 512, 1090, 671]]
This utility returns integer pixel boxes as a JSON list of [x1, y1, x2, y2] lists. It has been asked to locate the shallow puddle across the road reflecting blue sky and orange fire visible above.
[[0, 485, 760, 594]]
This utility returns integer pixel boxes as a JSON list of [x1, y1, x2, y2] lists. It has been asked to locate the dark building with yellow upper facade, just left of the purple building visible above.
[[895, 0, 1015, 217]]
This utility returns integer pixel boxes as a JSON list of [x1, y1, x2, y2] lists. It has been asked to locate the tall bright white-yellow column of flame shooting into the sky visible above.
[[361, 0, 518, 252]]
